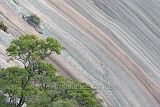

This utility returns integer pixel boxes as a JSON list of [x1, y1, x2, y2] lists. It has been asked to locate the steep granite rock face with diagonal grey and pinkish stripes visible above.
[[0, 0, 160, 107]]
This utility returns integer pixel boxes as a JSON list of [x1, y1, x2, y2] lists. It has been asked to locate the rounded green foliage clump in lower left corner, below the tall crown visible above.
[[0, 67, 38, 105]]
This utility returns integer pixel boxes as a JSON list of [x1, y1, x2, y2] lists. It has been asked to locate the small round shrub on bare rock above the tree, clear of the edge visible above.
[[27, 14, 41, 27]]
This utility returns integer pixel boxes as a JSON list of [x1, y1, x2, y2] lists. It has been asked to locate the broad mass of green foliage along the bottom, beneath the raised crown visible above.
[[0, 66, 101, 107]]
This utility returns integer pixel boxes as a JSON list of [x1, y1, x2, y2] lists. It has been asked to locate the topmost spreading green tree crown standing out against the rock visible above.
[[6, 35, 65, 70]]
